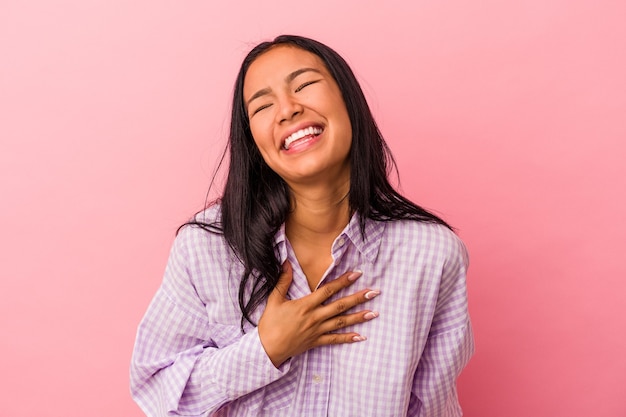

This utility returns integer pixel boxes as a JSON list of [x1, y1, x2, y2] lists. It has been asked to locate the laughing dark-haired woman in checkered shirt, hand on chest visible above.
[[131, 36, 473, 416]]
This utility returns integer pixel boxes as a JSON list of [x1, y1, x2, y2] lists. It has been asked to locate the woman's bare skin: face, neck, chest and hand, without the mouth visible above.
[[243, 46, 380, 367]]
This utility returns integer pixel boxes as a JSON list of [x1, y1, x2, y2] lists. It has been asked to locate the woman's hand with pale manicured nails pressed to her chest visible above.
[[259, 261, 380, 368]]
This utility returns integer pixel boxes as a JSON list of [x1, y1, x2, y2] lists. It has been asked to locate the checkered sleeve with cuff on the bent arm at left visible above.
[[130, 228, 289, 417]]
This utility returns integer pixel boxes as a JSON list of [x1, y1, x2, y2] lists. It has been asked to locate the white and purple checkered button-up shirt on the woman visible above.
[[131, 206, 474, 417]]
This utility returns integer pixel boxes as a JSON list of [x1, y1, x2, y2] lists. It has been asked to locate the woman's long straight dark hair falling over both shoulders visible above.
[[187, 35, 450, 330]]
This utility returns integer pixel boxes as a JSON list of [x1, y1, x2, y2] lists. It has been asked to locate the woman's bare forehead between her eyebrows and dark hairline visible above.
[[243, 45, 328, 95]]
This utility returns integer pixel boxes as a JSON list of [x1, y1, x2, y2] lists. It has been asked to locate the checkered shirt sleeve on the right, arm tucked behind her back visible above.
[[408, 232, 474, 417]]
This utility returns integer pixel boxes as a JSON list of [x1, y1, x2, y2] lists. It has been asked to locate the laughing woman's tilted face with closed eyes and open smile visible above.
[[243, 45, 352, 185]]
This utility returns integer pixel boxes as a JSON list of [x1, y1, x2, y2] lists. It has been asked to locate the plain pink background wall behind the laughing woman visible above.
[[0, 0, 626, 417]]
